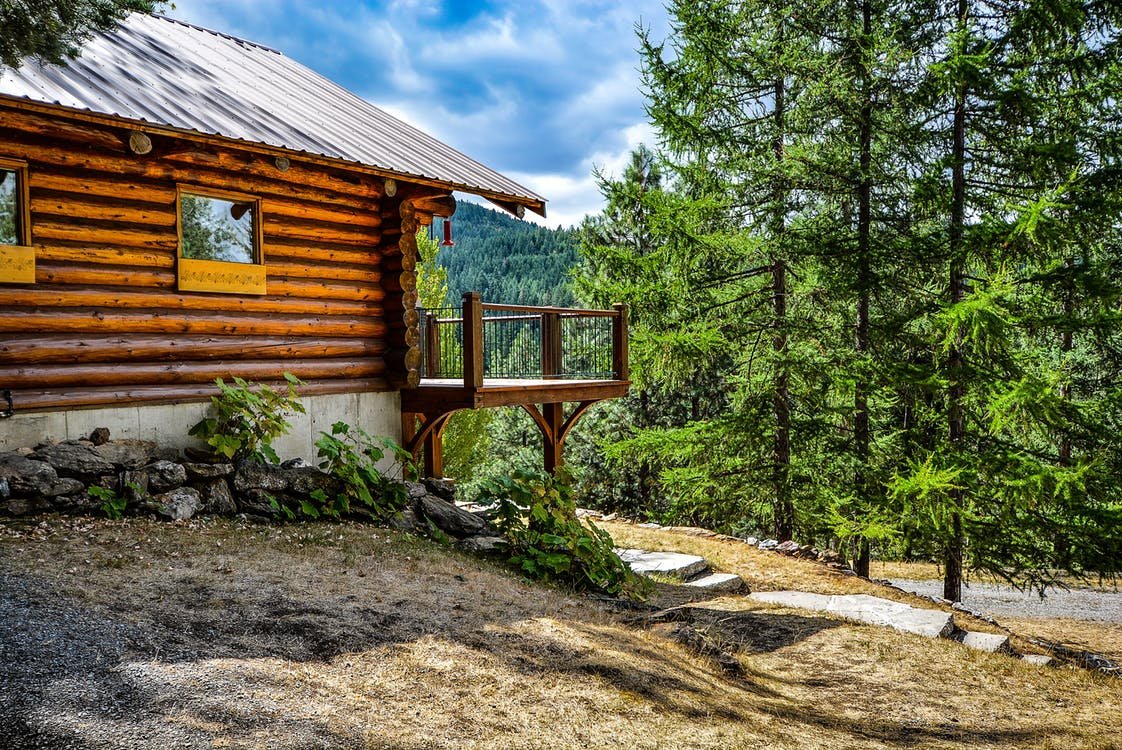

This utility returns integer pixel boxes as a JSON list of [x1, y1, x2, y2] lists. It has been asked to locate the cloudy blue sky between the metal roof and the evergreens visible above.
[[164, 0, 666, 226]]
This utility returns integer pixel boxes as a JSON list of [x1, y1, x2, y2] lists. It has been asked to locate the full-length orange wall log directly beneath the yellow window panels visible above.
[[0, 284, 381, 315]]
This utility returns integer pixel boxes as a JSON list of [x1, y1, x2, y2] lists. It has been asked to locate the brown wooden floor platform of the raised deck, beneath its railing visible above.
[[402, 377, 631, 413]]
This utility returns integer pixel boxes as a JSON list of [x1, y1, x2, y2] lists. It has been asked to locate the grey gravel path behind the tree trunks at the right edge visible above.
[[892, 579, 1122, 622]]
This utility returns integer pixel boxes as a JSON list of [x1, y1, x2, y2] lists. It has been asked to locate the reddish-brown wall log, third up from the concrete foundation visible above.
[[0, 336, 386, 365]]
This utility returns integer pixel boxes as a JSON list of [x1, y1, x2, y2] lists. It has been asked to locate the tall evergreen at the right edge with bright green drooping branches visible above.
[[900, 0, 1122, 601]]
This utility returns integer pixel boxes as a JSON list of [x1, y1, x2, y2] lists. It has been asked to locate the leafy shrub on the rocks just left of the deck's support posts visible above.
[[314, 422, 415, 518]]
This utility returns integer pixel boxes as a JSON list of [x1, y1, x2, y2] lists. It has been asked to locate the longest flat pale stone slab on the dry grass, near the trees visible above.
[[751, 592, 955, 638]]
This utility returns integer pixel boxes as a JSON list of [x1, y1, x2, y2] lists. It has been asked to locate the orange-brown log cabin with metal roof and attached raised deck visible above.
[[0, 15, 627, 476]]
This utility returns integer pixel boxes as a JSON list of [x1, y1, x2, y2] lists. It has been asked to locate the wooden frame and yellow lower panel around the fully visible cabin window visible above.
[[175, 183, 266, 295]]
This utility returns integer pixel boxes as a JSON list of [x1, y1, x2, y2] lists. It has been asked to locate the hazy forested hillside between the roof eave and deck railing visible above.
[[435, 201, 577, 305]]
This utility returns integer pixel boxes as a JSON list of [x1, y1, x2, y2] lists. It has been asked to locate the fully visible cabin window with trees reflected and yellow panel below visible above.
[[178, 188, 265, 294]]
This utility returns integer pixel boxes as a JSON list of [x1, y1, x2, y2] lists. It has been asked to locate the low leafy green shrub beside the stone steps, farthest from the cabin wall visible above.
[[480, 470, 644, 596]]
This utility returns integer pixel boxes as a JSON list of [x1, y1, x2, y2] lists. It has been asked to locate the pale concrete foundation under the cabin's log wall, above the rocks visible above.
[[0, 392, 402, 464]]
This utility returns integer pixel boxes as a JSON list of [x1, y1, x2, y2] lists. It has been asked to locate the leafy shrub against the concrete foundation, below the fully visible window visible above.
[[190, 373, 305, 464]]
